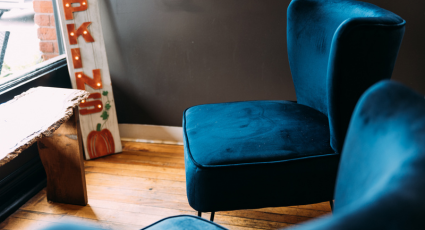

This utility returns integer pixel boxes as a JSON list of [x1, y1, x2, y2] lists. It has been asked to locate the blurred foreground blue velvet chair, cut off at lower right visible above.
[[146, 81, 425, 230]]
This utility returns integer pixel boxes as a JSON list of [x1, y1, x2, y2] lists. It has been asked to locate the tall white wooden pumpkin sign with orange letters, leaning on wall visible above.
[[56, 0, 122, 159]]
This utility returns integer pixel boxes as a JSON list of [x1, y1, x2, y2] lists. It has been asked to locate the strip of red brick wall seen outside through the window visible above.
[[33, 0, 59, 60]]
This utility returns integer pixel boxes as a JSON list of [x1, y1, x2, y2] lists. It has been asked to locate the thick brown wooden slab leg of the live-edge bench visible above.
[[38, 108, 87, 205]]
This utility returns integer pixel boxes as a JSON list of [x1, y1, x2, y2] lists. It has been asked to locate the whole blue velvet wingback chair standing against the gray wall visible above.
[[183, 0, 405, 218]]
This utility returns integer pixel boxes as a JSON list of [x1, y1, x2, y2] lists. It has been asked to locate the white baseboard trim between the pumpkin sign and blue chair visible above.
[[118, 124, 183, 145]]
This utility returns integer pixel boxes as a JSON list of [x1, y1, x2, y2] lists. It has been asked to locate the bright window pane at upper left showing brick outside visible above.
[[0, 0, 63, 85]]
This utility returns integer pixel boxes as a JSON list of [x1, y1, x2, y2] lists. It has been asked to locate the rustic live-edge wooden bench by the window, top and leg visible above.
[[0, 87, 89, 205]]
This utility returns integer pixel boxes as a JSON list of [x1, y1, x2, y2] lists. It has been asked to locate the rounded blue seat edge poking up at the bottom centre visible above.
[[142, 215, 227, 230]]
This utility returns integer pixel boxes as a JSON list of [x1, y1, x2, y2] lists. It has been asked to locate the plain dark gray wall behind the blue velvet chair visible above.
[[100, 0, 425, 126]]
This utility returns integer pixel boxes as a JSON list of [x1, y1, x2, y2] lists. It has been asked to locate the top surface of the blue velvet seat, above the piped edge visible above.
[[185, 101, 334, 166]]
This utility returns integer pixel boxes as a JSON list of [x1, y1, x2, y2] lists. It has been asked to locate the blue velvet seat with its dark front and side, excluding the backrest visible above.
[[183, 101, 339, 212]]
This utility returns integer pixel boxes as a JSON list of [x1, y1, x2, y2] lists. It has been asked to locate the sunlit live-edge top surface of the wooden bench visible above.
[[0, 87, 89, 166]]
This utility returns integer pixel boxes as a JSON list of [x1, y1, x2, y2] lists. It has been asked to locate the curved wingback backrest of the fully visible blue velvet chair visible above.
[[287, 0, 405, 153]]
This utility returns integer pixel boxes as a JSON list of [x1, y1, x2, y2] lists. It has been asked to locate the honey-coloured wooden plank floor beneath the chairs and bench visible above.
[[0, 142, 330, 230]]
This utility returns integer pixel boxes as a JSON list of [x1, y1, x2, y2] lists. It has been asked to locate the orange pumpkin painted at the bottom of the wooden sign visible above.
[[87, 124, 115, 159]]
